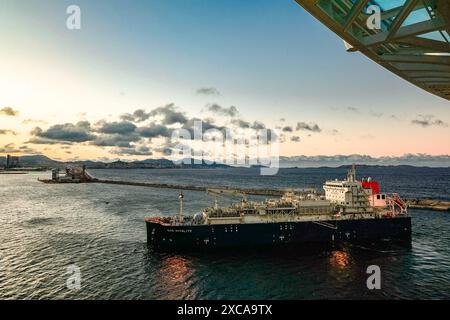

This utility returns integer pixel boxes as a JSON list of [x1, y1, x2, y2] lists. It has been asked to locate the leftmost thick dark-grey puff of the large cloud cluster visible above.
[[31, 121, 95, 142]]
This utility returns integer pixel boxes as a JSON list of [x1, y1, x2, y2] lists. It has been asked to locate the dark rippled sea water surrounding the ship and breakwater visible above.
[[0, 168, 450, 299]]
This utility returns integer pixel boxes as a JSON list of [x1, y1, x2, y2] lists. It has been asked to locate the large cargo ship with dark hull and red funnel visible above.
[[145, 166, 411, 250]]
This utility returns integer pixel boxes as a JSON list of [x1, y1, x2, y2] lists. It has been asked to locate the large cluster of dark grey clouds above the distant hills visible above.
[[23, 103, 278, 155]]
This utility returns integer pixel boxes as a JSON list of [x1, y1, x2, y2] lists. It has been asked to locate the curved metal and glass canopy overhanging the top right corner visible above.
[[296, 0, 450, 100]]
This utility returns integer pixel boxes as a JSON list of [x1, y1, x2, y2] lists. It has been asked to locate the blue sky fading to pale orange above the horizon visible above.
[[0, 0, 450, 160]]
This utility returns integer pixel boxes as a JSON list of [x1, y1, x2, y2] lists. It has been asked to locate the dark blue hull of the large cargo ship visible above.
[[146, 216, 411, 250]]
